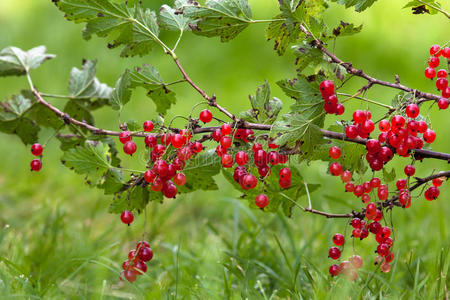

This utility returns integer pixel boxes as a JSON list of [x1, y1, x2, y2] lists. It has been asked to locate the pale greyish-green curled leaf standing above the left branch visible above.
[[69, 60, 113, 99]]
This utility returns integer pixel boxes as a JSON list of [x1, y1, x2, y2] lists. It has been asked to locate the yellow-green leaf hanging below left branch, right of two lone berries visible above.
[[61, 141, 112, 185]]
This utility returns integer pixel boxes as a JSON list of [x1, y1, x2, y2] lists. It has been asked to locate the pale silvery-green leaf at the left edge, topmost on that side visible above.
[[0, 46, 55, 77]]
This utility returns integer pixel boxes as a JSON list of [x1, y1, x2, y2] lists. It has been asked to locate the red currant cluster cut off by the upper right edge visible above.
[[425, 45, 450, 109]]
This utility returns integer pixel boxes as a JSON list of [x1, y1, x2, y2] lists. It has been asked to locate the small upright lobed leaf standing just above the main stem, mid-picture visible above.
[[240, 81, 283, 124]]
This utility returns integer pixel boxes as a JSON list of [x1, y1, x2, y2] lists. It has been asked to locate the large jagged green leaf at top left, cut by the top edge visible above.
[[53, 0, 159, 57]]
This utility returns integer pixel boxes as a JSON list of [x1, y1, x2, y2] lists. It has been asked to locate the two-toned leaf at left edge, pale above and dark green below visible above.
[[0, 94, 40, 145]]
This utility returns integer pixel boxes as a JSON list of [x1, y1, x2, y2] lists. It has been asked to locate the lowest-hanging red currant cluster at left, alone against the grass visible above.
[[120, 241, 153, 282]]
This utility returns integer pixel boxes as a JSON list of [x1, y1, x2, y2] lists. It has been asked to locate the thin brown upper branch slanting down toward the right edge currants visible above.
[[300, 25, 441, 102]]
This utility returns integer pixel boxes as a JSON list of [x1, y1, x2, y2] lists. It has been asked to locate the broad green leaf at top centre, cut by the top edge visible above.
[[183, 0, 252, 42]]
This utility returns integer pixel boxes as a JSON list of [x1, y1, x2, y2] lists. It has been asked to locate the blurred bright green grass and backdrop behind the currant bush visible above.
[[0, 0, 450, 299]]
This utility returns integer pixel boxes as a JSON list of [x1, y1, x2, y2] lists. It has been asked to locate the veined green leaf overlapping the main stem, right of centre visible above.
[[270, 114, 324, 152]]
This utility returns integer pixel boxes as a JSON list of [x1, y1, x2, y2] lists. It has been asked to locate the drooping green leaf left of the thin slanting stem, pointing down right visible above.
[[130, 65, 177, 114]]
